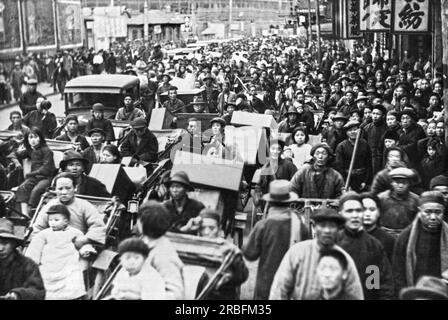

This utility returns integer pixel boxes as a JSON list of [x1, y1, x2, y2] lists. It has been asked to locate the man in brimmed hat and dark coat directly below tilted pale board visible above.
[[163, 171, 205, 234]]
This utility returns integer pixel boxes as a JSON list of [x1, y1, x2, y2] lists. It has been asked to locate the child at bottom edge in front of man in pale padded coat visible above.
[[316, 249, 357, 300]]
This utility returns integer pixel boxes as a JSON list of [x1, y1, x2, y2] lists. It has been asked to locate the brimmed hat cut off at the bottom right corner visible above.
[[400, 276, 448, 300]]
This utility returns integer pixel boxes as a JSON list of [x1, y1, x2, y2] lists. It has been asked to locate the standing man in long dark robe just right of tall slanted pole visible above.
[[363, 104, 387, 175]]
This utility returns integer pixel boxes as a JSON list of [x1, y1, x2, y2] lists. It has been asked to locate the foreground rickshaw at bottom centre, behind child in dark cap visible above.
[[93, 232, 242, 300]]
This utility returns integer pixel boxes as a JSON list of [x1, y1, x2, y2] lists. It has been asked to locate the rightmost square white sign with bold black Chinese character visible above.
[[393, 0, 430, 33]]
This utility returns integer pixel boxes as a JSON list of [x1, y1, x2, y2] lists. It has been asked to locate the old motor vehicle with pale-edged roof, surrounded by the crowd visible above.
[[56, 74, 141, 134]]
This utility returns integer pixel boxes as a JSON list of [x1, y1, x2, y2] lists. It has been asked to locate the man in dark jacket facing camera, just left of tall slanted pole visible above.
[[291, 143, 344, 199]]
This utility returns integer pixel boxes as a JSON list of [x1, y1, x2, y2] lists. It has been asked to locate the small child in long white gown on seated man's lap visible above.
[[25, 204, 92, 300]]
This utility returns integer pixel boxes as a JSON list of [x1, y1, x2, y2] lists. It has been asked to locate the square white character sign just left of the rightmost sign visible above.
[[359, 0, 392, 32]]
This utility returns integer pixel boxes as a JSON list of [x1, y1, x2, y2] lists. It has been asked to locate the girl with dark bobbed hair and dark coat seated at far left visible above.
[[16, 128, 56, 216]]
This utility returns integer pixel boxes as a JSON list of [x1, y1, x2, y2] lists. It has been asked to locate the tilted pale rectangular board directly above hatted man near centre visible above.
[[171, 151, 244, 191]]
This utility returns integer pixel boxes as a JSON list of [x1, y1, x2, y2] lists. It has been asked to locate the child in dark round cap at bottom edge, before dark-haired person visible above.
[[106, 238, 166, 300]]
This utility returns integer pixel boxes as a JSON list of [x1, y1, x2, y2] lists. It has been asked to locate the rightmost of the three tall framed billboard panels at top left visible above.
[[58, 1, 82, 46]]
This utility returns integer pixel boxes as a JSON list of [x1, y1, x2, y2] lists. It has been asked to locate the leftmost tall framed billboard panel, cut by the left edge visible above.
[[0, 0, 21, 50]]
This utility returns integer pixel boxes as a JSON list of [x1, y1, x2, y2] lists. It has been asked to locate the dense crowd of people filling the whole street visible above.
[[0, 37, 448, 300]]
